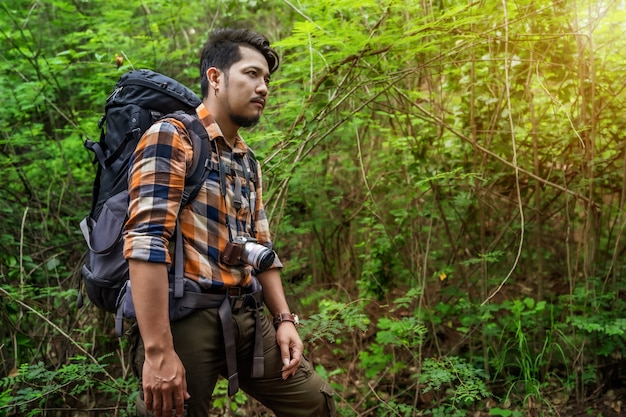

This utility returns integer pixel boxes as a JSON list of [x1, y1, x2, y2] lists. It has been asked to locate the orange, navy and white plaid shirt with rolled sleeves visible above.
[[124, 104, 282, 290]]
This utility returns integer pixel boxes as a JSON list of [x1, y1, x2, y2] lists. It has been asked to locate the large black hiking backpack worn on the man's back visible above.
[[78, 70, 211, 327]]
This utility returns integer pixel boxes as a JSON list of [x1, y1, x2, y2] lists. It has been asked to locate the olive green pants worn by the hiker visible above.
[[131, 307, 336, 417]]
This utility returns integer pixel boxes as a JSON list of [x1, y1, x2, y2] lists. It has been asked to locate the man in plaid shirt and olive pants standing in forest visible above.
[[124, 29, 336, 417]]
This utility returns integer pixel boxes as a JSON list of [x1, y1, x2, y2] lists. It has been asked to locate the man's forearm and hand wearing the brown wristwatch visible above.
[[257, 269, 304, 379]]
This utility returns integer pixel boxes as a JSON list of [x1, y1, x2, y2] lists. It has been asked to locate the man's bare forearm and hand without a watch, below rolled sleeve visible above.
[[128, 259, 189, 417]]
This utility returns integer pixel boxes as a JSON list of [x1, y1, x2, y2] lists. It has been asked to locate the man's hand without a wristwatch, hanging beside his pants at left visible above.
[[142, 350, 189, 417]]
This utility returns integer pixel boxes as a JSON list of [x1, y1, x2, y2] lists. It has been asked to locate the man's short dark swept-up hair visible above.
[[200, 28, 280, 98]]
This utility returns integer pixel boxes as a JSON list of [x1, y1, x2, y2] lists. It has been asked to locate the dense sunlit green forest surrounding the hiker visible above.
[[0, 0, 626, 417]]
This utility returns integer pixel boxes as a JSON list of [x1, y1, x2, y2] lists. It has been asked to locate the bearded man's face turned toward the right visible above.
[[220, 47, 270, 127]]
